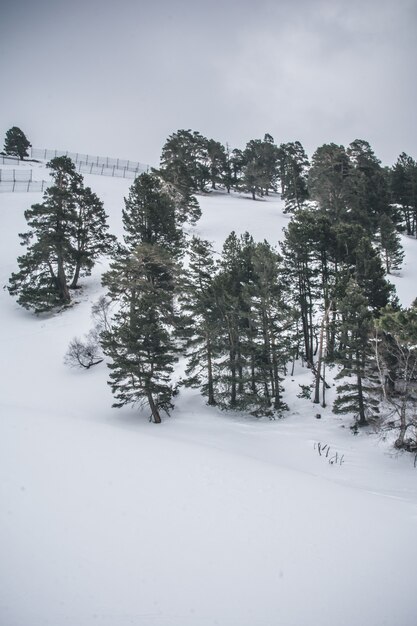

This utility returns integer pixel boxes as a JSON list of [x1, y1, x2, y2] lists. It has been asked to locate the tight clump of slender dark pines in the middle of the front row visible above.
[[213, 232, 293, 415]]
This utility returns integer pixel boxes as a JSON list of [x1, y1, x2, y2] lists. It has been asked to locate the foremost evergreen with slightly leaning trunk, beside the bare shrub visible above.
[[101, 243, 176, 423]]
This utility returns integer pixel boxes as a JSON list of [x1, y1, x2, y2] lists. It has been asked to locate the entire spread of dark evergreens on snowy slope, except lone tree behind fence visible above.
[[9, 131, 417, 448]]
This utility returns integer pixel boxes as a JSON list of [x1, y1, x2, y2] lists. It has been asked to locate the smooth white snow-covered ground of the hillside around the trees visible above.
[[0, 162, 417, 626]]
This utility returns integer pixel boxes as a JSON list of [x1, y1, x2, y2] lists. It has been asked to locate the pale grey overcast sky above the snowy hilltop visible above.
[[0, 0, 417, 165]]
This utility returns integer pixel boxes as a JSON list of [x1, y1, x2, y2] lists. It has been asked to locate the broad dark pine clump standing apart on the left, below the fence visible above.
[[8, 157, 114, 312]]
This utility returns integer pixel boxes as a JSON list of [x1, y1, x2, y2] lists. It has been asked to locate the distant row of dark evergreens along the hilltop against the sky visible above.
[[159, 130, 417, 239]]
